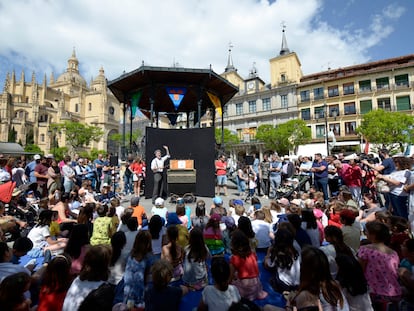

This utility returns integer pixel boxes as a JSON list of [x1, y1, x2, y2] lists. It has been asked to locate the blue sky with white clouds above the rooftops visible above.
[[0, 0, 414, 88]]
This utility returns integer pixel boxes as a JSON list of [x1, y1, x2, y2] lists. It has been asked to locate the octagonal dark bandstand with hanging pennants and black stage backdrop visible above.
[[108, 64, 238, 198]]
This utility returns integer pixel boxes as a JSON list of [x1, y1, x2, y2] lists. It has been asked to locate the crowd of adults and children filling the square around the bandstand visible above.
[[0, 150, 414, 311]]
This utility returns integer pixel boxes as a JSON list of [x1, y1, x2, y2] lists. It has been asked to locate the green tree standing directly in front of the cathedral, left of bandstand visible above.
[[50, 121, 103, 152]]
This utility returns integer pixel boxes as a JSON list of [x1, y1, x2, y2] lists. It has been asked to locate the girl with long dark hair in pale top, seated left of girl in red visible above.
[[183, 227, 210, 290]]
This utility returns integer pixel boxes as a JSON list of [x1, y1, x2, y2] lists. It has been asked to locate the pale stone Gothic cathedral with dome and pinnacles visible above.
[[0, 51, 121, 154]]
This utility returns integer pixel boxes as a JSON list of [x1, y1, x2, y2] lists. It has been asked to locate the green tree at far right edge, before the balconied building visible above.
[[356, 109, 414, 151]]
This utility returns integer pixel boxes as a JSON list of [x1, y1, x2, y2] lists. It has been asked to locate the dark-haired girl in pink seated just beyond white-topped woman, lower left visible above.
[[65, 224, 90, 276]]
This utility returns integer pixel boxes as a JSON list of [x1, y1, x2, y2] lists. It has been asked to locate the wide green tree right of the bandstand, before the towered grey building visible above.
[[256, 120, 312, 154]]
